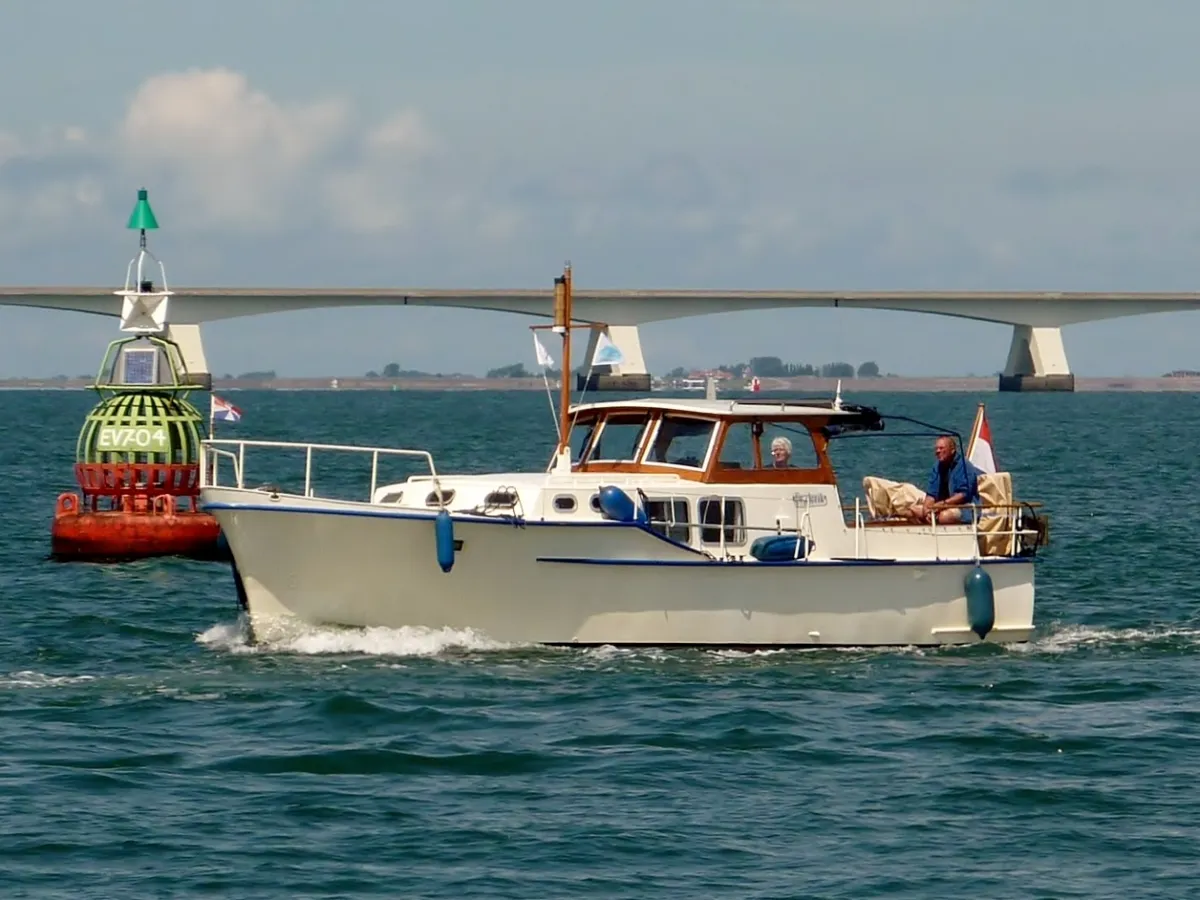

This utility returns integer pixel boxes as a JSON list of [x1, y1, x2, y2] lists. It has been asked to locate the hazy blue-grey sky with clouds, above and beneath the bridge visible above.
[[0, 0, 1200, 377]]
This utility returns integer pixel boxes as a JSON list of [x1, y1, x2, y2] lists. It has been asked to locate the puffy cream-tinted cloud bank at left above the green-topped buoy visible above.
[[0, 68, 520, 250]]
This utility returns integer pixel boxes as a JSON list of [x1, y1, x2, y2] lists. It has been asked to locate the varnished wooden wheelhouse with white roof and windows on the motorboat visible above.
[[559, 398, 883, 485]]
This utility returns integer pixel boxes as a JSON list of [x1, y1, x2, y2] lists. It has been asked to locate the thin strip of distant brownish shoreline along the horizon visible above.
[[0, 376, 1200, 396]]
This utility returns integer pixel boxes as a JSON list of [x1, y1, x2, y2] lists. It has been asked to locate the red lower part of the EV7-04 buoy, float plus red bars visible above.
[[50, 463, 227, 562]]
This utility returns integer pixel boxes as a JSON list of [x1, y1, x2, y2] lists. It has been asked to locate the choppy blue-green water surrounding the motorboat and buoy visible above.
[[0, 392, 1200, 899]]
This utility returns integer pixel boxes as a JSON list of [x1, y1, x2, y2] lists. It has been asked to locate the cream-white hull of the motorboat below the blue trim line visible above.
[[204, 488, 1033, 647]]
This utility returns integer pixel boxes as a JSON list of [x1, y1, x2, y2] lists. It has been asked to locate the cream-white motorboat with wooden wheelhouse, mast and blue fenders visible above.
[[200, 270, 1045, 648]]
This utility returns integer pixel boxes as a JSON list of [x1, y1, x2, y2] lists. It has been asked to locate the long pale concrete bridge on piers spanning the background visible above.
[[0, 283, 1200, 391]]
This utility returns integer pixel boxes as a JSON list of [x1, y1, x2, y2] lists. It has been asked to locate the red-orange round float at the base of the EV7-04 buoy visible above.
[[50, 493, 228, 562]]
